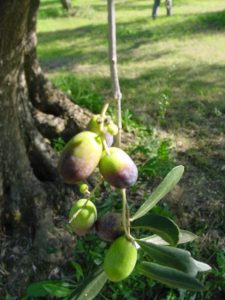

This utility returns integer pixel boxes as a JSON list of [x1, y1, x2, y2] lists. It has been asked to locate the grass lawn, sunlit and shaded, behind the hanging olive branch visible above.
[[38, 0, 225, 300]]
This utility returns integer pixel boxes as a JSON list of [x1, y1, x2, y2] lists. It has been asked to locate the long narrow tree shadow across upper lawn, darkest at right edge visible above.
[[39, 10, 225, 43]]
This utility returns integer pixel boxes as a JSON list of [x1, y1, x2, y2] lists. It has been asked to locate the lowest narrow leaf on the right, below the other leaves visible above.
[[137, 262, 204, 291]]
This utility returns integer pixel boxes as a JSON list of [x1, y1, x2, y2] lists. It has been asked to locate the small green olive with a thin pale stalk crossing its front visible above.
[[69, 199, 97, 236]]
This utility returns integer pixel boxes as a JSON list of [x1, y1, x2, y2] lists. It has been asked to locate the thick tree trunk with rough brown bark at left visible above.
[[0, 0, 90, 299]]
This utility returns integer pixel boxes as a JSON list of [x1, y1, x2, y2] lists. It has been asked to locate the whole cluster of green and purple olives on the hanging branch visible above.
[[59, 114, 138, 281]]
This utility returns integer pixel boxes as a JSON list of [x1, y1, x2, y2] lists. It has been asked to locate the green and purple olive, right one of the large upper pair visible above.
[[99, 147, 138, 188]]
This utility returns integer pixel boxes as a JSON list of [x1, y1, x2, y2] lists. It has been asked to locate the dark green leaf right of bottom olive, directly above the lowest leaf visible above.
[[137, 240, 198, 276]]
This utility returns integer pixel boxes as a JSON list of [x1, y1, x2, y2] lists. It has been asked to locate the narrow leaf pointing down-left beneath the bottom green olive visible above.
[[71, 268, 107, 300]]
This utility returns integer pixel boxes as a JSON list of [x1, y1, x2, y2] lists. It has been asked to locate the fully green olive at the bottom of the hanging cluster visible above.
[[103, 236, 137, 282]]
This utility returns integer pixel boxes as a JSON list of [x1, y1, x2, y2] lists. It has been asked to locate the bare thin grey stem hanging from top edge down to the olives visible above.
[[108, 0, 122, 147]]
